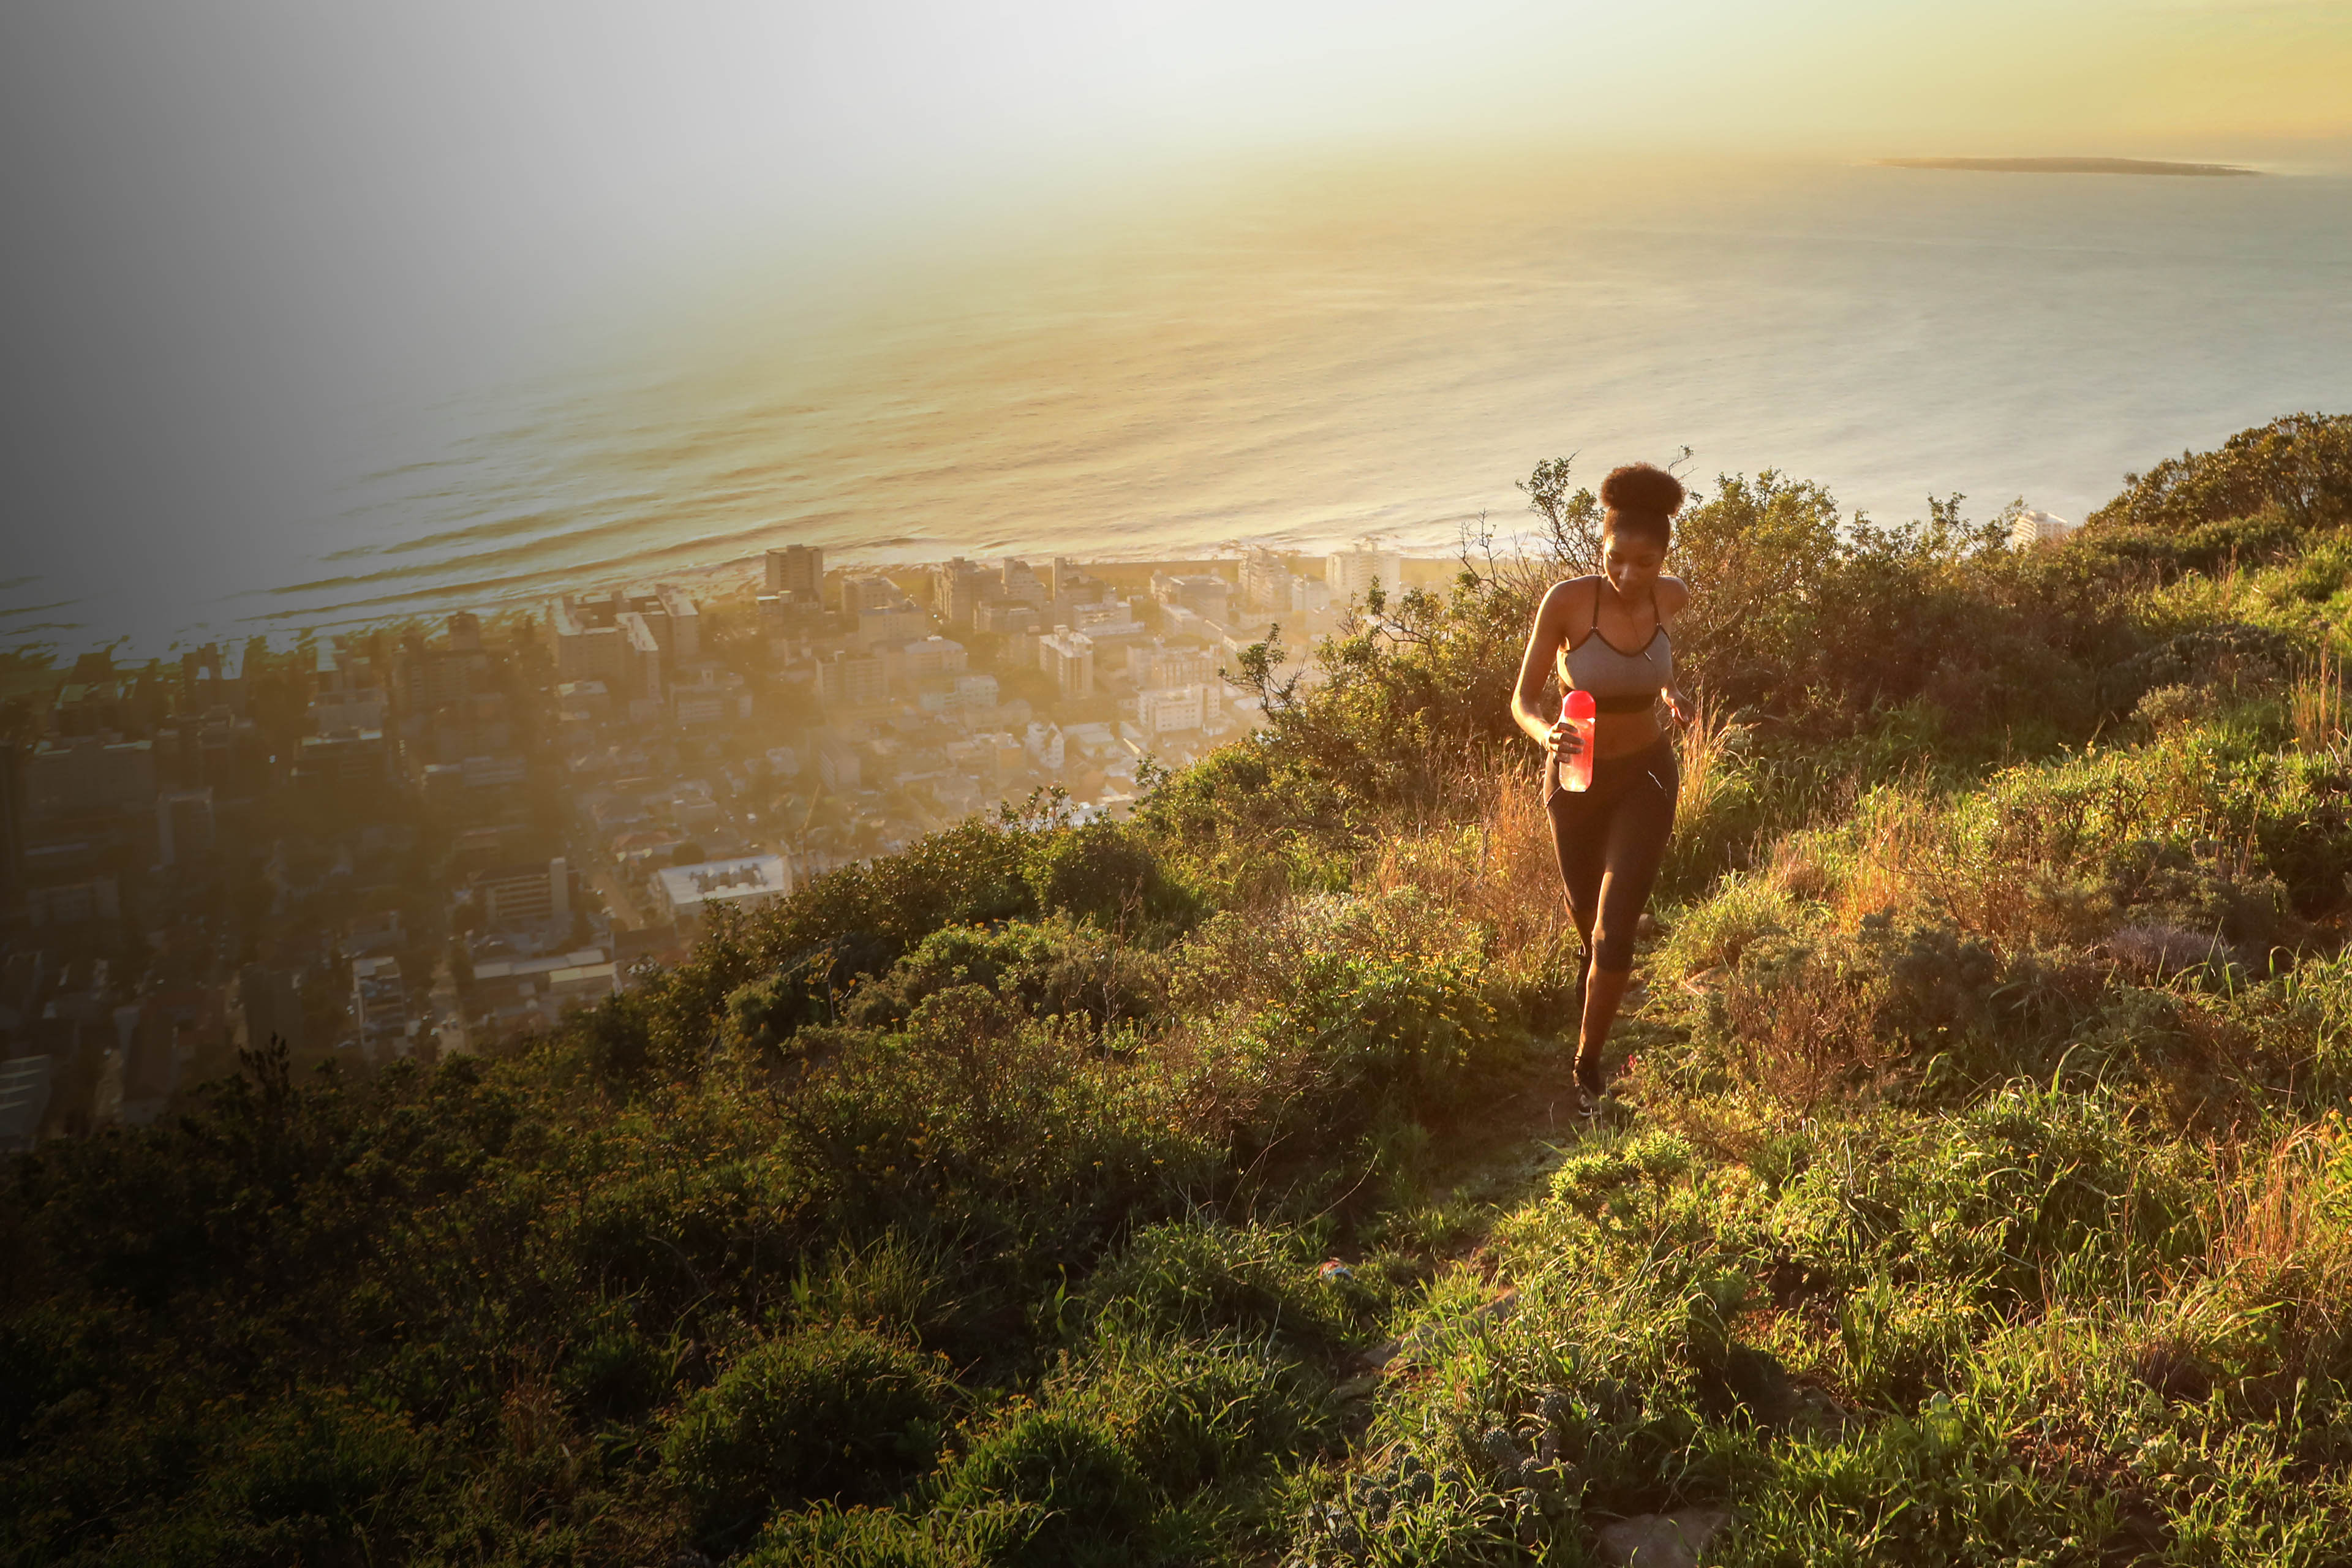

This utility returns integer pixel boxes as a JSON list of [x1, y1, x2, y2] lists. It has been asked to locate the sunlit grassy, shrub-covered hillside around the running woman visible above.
[[0, 416, 2352, 1568]]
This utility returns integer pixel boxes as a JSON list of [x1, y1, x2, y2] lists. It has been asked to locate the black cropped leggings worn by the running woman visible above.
[[1545, 736, 1682, 971]]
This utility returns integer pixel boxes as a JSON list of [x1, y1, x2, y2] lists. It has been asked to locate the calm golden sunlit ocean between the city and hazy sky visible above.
[[0, 155, 2352, 637]]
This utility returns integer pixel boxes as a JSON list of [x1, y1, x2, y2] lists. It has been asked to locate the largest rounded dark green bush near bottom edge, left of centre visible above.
[[661, 1324, 955, 1542]]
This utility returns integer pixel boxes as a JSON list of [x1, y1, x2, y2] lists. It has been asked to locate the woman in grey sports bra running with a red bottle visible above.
[[1510, 463, 1691, 1110]]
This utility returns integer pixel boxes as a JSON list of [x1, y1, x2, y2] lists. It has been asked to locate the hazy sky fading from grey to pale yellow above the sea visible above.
[[0, 0, 2352, 637]]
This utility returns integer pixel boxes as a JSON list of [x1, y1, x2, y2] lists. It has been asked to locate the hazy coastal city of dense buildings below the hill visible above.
[[0, 543, 1449, 1150]]
